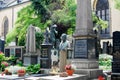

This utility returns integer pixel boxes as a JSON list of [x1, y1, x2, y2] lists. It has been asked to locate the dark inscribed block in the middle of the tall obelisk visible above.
[[74, 39, 96, 59]]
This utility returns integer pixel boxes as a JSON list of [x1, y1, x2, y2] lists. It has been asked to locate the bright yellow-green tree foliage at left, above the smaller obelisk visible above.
[[6, 5, 44, 46]]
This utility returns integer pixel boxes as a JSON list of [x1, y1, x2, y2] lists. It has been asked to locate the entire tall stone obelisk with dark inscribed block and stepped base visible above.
[[72, 0, 102, 80]]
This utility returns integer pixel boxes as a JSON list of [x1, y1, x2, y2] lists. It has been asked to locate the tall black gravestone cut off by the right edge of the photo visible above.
[[111, 31, 120, 80]]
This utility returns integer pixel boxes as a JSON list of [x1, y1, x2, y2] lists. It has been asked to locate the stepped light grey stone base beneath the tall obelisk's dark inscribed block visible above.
[[71, 59, 103, 79]]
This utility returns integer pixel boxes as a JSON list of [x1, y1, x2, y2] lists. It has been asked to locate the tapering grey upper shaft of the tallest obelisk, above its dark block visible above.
[[74, 0, 93, 37]]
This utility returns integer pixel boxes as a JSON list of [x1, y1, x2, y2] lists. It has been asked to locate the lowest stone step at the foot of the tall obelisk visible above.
[[75, 69, 103, 79]]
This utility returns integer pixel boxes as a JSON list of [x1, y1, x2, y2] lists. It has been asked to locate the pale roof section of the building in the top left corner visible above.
[[0, 0, 29, 9]]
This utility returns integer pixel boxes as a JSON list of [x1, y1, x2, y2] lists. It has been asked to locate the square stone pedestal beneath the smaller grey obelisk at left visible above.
[[23, 54, 38, 66]]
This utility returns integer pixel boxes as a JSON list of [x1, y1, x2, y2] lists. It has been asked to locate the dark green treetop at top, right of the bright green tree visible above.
[[31, 0, 60, 23]]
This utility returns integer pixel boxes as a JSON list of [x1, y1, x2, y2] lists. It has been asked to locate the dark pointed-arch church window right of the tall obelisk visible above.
[[96, 0, 110, 38]]
